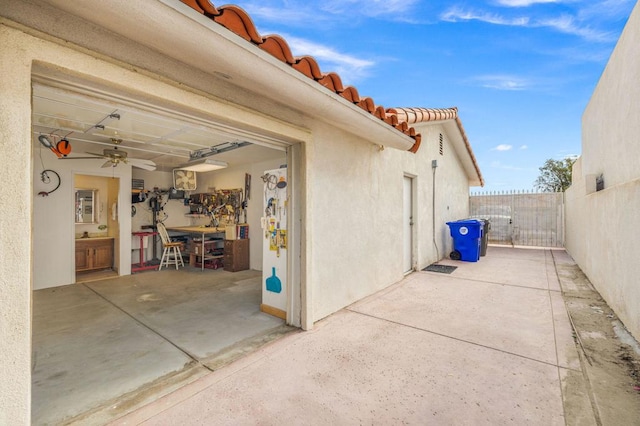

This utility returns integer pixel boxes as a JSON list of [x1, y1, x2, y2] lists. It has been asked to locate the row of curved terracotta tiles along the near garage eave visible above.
[[181, 0, 420, 153]]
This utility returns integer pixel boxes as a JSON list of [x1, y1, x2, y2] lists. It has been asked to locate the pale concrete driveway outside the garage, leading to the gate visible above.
[[114, 247, 594, 425]]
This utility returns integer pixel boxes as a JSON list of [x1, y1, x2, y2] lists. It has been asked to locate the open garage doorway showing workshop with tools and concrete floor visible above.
[[32, 82, 300, 424]]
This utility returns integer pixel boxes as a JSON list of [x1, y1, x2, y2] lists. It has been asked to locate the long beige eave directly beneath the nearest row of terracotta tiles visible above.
[[35, 0, 416, 151]]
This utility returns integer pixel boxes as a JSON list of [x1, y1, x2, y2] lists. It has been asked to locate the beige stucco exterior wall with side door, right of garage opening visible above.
[[306, 120, 469, 321]]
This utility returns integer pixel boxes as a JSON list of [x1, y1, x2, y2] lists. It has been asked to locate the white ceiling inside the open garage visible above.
[[32, 85, 284, 171]]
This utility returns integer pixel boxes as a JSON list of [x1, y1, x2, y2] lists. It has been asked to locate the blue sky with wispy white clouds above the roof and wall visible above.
[[234, 0, 636, 192]]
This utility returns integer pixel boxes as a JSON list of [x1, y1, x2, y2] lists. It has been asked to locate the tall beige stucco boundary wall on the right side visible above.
[[566, 1, 640, 339]]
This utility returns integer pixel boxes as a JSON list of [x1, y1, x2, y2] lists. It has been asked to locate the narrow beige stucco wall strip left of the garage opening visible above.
[[0, 26, 33, 425]]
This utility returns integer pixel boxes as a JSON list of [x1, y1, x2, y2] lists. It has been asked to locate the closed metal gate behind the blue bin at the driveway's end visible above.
[[469, 191, 564, 247]]
